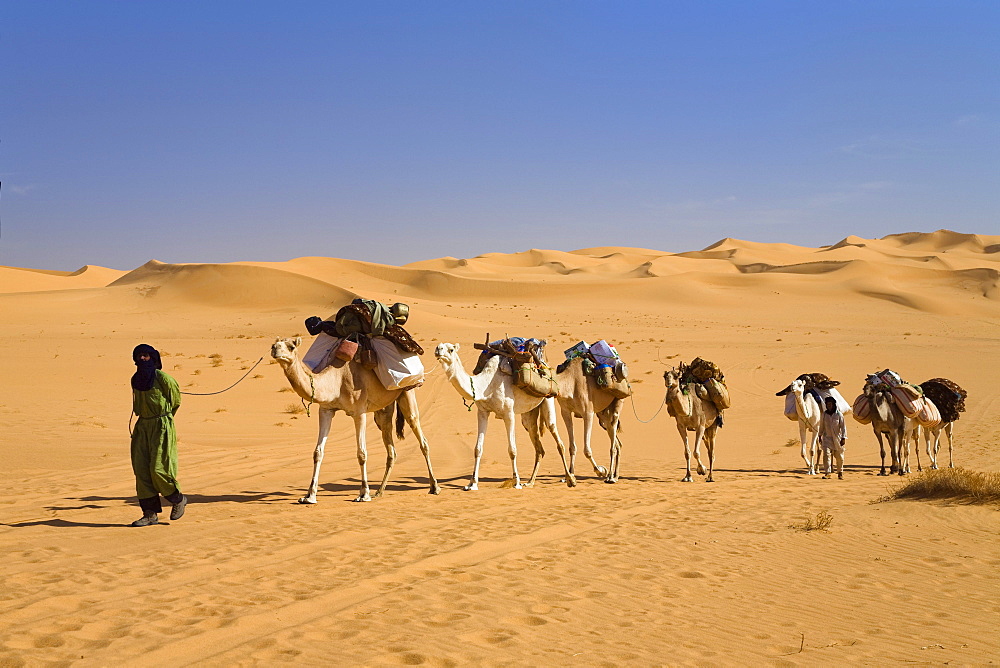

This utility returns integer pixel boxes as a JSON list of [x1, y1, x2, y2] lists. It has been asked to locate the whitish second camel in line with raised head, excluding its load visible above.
[[434, 343, 576, 491]]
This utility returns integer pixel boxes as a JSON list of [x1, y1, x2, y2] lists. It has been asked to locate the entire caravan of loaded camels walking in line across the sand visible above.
[[271, 299, 967, 504]]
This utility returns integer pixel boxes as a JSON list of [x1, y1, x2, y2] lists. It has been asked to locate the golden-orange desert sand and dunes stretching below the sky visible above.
[[0, 230, 1000, 666]]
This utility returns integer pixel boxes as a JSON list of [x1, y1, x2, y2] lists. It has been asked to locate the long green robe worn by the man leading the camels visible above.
[[132, 369, 181, 499]]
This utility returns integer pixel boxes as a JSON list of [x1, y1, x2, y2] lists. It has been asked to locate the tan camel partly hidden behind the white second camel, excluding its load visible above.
[[556, 358, 624, 484]]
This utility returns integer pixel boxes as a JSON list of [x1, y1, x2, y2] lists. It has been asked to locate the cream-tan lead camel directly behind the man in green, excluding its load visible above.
[[271, 337, 441, 504]]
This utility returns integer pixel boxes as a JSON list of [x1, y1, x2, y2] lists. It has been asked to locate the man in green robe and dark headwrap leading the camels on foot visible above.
[[132, 343, 187, 527]]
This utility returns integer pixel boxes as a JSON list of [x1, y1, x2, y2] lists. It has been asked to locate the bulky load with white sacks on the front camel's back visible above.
[[302, 299, 424, 390]]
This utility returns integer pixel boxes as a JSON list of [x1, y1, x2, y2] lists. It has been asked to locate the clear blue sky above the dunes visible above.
[[0, 0, 1000, 270]]
